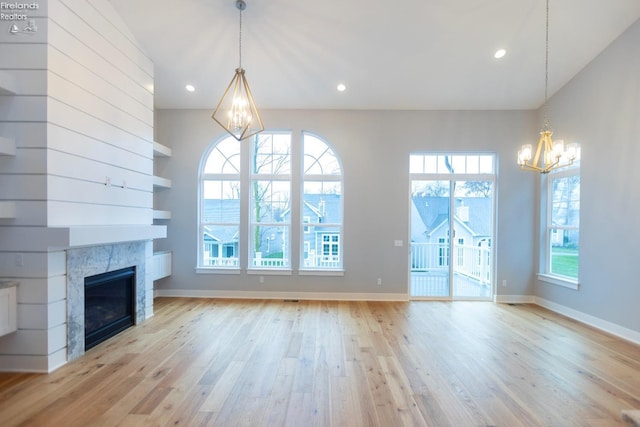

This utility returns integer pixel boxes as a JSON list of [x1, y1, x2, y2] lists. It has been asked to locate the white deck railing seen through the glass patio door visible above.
[[411, 243, 491, 284]]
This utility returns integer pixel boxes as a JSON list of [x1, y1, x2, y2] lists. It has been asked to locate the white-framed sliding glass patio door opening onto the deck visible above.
[[409, 155, 494, 300]]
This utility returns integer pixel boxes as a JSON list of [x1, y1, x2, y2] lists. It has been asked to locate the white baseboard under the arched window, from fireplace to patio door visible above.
[[155, 289, 409, 301]]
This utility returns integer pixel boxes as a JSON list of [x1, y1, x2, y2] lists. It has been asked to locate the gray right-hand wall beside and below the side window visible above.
[[535, 21, 640, 331]]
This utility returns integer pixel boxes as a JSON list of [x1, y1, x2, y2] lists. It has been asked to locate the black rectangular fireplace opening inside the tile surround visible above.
[[84, 267, 136, 351]]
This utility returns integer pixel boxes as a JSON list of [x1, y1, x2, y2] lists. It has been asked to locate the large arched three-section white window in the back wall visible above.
[[198, 132, 343, 272]]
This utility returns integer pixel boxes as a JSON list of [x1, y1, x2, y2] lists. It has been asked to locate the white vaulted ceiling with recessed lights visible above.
[[110, 0, 640, 110]]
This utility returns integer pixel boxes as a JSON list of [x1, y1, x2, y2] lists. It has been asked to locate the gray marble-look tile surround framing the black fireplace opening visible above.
[[67, 241, 153, 361]]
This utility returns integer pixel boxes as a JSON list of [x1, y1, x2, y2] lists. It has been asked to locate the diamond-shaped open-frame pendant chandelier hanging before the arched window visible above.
[[211, 0, 264, 141]]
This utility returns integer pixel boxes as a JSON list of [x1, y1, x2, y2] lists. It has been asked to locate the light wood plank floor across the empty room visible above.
[[0, 298, 640, 427]]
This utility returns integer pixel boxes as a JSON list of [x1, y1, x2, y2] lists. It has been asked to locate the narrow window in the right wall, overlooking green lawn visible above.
[[540, 167, 580, 289]]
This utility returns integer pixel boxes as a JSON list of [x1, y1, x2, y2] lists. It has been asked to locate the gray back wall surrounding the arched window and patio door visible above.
[[155, 110, 538, 296]]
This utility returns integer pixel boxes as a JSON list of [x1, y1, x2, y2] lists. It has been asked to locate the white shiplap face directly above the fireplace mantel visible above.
[[47, 0, 153, 227]]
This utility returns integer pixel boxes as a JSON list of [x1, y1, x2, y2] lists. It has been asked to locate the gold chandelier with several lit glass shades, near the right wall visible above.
[[518, 0, 578, 173]]
